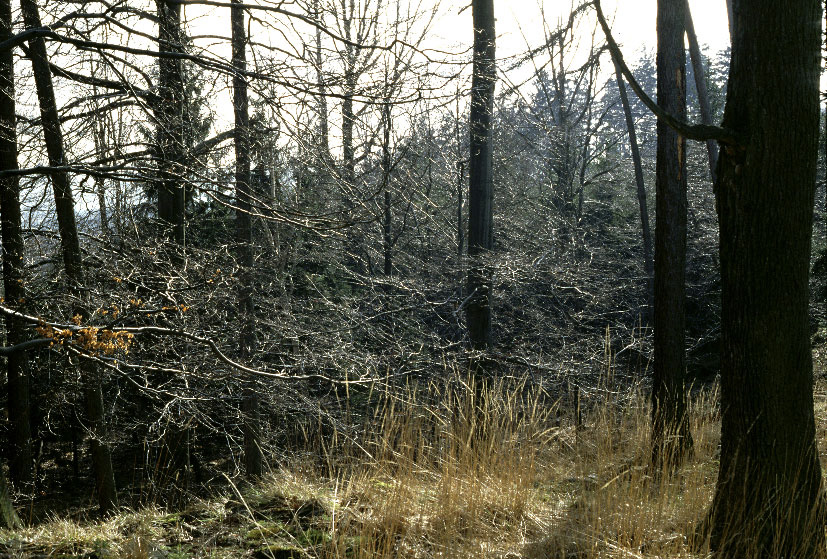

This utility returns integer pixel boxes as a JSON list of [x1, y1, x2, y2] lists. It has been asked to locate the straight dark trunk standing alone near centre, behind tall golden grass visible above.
[[465, 0, 497, 349]]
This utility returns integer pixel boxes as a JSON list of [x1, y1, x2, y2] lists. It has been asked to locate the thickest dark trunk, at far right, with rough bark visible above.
[[711, 0, 825, 558]]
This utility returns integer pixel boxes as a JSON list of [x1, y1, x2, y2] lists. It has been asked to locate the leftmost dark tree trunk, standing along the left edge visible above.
[[0, 0, 33, 489]]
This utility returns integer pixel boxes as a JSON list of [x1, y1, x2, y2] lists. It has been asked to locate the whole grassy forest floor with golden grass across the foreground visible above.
[[0, 347, 827, 559]]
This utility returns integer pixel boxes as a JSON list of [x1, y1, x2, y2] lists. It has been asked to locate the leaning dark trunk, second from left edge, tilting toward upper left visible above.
[[20, 0, 118, 514]]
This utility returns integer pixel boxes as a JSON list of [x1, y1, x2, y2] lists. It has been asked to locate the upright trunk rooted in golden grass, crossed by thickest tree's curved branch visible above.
[[652, 0, 692, 470]]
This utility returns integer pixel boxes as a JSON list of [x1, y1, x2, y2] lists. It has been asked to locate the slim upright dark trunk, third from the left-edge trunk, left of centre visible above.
[[230, 0, 263, 477]]
